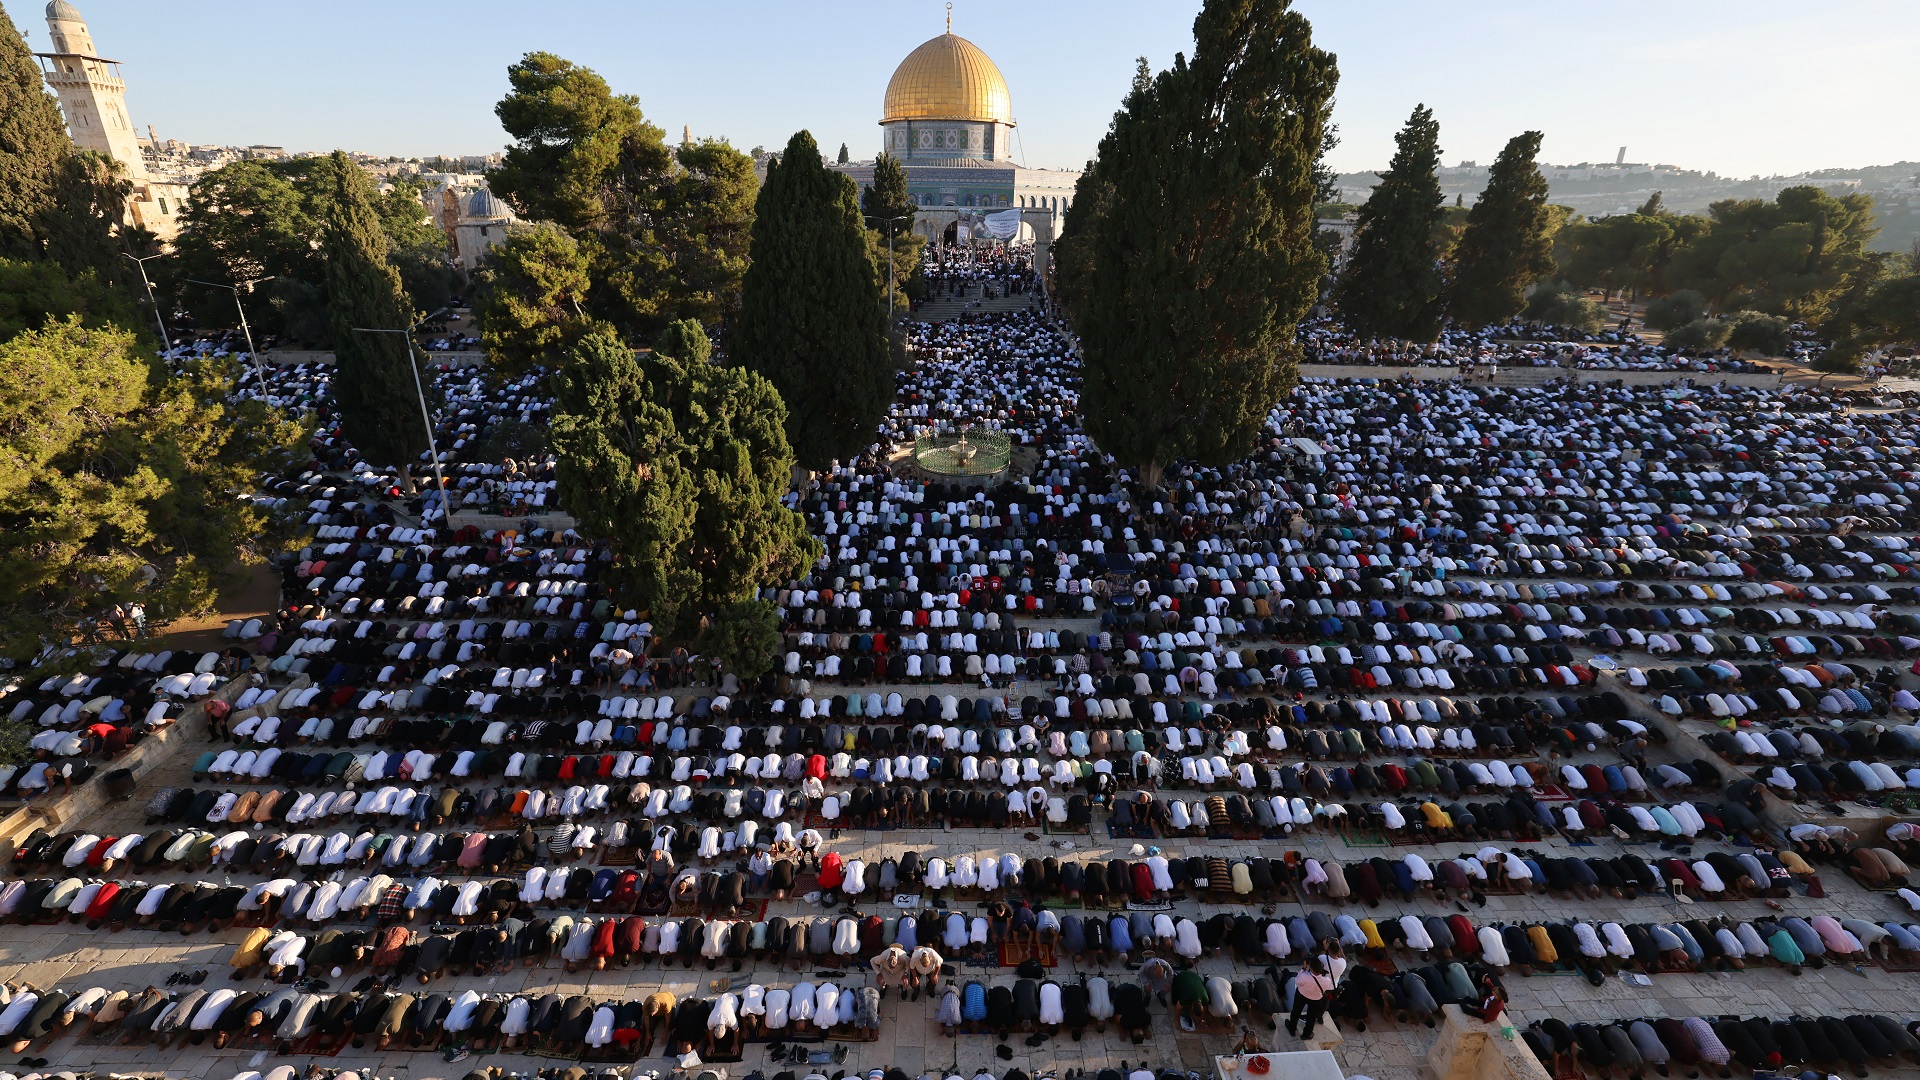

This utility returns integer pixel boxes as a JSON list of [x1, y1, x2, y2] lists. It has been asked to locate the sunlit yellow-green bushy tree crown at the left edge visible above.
[[0, 315, 305, 657]]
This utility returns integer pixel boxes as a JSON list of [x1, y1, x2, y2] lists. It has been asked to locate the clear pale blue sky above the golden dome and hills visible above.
[[18, 0, 1920, 177]]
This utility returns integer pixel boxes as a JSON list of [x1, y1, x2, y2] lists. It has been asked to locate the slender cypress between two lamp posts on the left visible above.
[[321, 150, 426, 477]]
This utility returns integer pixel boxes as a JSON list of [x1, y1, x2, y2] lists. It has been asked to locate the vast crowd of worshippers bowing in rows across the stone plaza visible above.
[[11, 303, 1920, 1080]]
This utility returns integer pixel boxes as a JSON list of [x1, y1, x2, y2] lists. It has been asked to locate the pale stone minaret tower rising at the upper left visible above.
[[36, 0, 186, 240]]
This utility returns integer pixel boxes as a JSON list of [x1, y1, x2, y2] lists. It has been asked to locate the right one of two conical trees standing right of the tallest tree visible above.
[[1452, 131, 1553, 329]]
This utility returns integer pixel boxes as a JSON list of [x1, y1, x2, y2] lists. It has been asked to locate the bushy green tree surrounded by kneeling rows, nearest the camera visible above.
[[553, 321, 820, 636]]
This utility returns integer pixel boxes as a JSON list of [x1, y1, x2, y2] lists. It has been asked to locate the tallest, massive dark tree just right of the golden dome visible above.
[[1056, 0, 1338, 482]]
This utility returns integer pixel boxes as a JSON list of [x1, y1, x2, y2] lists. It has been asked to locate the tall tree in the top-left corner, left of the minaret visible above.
[[0, 8, 73, 259]]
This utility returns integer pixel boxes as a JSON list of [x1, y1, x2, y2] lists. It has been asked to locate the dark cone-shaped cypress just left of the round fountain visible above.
[[733, 131, 893, 469]]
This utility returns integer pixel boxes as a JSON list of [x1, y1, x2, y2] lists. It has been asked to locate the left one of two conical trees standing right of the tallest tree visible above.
[[1334, 106, 1446, 342]]
